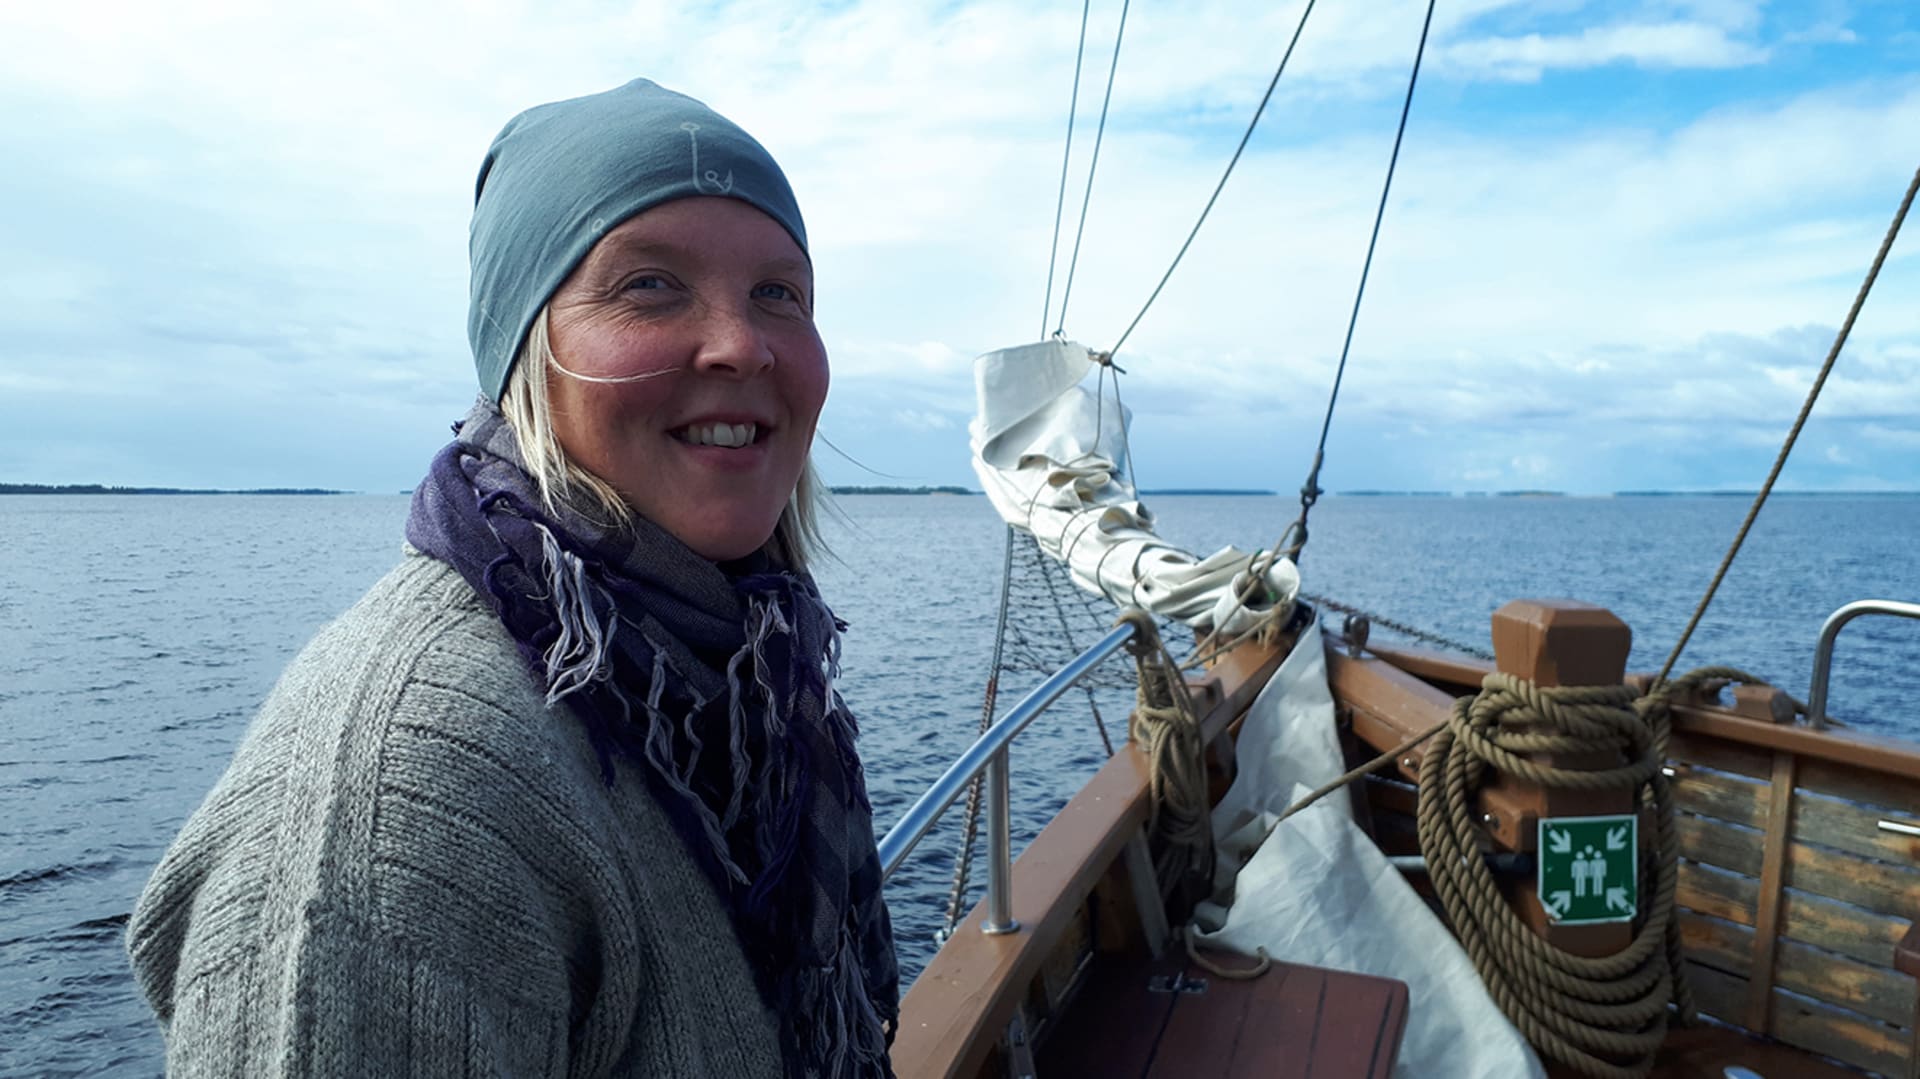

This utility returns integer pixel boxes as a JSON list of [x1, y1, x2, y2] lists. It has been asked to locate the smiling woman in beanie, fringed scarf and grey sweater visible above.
[[129, 81, 899, 1077]]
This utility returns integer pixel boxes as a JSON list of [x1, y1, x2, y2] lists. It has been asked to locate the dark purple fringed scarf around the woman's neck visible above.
[[407, 401, 900, 1079]]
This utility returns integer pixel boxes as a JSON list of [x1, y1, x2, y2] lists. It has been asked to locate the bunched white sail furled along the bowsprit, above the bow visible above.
[[970, 338, 1300, 634]]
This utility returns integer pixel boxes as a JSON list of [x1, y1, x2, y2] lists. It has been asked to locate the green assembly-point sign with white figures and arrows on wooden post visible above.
[[1538, 814, 1640, 925]]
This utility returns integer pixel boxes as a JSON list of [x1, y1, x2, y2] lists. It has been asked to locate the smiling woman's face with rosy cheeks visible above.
[[547, 198, 828, 561]]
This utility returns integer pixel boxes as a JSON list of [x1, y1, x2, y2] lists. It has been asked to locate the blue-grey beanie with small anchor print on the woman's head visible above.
[[467, 79, 806, 403]]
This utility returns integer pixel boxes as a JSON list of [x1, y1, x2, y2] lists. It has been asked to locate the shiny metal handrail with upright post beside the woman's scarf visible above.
[[879, 622, 1133, 933]]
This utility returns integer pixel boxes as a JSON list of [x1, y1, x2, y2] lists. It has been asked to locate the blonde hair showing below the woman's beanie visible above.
[[499, 307, 826, 572]]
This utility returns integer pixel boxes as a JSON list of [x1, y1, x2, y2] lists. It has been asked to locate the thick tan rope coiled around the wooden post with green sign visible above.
[[1419, 668, 1755, 1079]]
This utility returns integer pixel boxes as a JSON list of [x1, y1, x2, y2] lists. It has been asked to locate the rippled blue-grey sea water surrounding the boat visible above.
[[0, 495, 1920, 1075]]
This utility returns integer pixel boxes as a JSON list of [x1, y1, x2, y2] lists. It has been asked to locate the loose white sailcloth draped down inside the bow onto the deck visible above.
[[1188, 626, 1544, 1079]]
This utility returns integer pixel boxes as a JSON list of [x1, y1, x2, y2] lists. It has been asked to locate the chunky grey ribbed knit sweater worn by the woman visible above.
[[127, 553, 780, 1079]]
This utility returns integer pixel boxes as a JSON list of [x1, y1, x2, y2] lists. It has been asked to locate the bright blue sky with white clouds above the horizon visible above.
[[0, 0, 1920, 492]]
